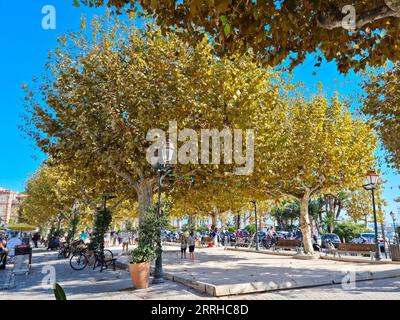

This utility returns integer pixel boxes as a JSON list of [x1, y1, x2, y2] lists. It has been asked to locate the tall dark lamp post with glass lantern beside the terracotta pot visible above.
[[152, 142, 175, 284]]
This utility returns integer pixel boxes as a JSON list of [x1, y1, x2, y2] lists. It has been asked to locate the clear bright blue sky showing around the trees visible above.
[[0, 0, 400, 221]]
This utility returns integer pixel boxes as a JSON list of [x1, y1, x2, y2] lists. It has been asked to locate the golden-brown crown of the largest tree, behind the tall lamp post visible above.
[[22, 17, 282, 222]]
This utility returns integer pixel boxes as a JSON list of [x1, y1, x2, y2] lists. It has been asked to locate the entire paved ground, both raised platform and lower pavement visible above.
[[0, 246, 400, 300]]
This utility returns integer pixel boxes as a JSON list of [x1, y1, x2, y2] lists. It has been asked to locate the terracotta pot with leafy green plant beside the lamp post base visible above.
[[128, 244, 155, 289]]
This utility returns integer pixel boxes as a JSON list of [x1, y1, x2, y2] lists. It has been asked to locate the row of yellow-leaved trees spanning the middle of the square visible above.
[[21, 16, 377, 253]]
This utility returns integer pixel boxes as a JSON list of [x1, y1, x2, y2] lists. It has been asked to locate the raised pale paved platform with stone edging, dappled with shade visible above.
[[118, 248, 400, 296]]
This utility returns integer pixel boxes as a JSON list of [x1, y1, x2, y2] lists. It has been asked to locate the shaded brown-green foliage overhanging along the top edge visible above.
[[78, 0, 400, 72]]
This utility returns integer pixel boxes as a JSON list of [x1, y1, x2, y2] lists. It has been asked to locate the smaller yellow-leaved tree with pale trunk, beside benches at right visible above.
[[252, 95, 377, 252]]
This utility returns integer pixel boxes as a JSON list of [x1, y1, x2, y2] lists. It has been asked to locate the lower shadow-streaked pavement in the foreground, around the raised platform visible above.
[[0, 248, 400, 300]]
